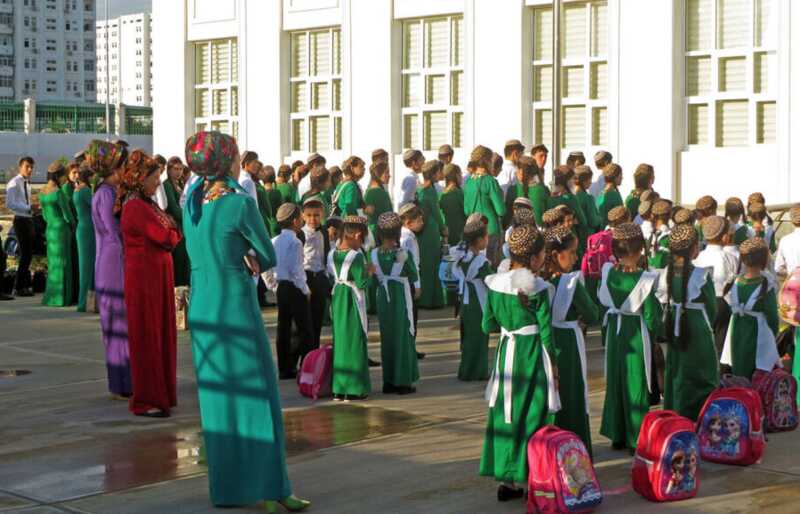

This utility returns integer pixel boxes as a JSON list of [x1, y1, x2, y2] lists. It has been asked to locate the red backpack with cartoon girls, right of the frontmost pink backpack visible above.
[[631, 410, 700, 502]]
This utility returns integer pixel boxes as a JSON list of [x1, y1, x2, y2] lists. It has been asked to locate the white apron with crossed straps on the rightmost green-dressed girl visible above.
[[720, 283, 782, 371]]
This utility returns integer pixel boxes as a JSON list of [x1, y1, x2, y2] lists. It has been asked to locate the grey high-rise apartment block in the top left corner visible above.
[[0, 0, 96, 102]]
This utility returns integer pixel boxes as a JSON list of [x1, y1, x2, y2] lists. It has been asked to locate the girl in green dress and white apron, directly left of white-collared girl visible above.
[[451, 214, 494, 381]]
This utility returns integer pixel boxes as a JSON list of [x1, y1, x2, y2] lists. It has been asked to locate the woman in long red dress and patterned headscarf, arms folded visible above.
[[117, 150, 181, 418]]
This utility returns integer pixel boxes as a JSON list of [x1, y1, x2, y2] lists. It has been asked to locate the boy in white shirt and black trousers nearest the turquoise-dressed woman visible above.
[[272, 203, 311, 380]]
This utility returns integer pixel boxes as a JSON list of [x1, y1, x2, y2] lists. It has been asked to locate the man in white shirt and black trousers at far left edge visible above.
[[6, 156, 37, 296]]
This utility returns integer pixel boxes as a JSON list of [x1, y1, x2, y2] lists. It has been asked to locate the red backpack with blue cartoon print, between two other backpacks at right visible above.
[[697, 387, 766, 466]]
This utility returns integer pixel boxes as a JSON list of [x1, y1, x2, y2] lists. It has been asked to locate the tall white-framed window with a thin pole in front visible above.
[[532, 0, 608, 150]]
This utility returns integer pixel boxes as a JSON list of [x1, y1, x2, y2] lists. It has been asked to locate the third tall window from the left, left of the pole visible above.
[[402, 15, 465, 150]]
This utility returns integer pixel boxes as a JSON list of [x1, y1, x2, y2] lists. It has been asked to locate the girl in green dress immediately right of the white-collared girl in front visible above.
[[542, 227, 599, 455]]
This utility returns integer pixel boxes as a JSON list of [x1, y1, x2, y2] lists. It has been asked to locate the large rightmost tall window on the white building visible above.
[[685, 0, 777, 147]]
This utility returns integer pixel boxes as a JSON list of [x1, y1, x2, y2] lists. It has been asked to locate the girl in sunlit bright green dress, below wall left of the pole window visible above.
[[464, 145, 506, 266]]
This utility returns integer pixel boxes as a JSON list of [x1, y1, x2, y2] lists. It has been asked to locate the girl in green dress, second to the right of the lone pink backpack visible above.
[[370, 211, 419, 394]]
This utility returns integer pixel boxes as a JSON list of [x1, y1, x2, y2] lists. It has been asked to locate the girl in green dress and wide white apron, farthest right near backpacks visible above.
[[720, 236, 781, 377]]
